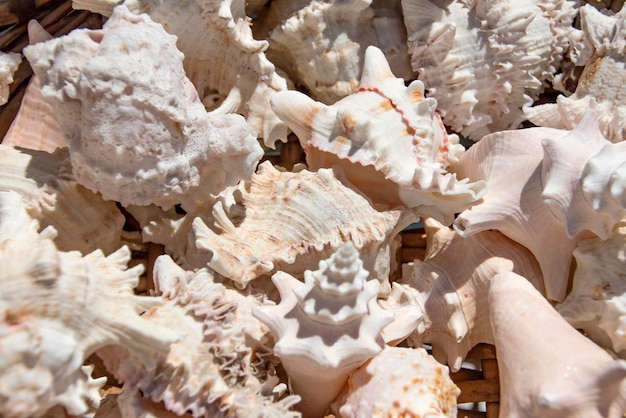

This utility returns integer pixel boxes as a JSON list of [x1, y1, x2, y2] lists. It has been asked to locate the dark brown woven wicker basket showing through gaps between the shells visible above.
[[0, 0, 500, 418]]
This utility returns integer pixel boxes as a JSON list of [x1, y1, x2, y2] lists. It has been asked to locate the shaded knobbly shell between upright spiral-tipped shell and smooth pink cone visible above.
[[387, 219, 543, 371]]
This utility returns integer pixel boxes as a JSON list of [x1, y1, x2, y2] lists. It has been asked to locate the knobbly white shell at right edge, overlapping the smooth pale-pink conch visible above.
[[541, 110, 626, 239]]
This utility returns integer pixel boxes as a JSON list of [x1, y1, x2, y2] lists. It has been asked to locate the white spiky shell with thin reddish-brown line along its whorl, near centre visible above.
[[271, 47, 485, 223]]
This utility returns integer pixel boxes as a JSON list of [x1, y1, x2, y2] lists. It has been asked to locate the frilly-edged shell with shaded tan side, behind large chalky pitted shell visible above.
[[124, 0, 289, 148]]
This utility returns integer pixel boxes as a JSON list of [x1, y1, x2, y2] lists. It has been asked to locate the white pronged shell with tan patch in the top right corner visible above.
[[524, 5, 626, 142]]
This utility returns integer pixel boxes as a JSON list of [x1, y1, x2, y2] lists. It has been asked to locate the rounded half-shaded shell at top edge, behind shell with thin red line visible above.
[[267, 0, 414, 104]]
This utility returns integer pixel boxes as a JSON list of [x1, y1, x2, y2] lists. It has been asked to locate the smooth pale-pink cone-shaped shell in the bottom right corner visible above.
[[489, 272, 626, 418]]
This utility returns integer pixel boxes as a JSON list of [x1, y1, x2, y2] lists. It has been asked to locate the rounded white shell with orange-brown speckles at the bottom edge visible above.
[[331, 346, 461, 418]]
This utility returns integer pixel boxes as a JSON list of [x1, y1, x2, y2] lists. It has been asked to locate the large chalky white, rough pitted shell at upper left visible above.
[[24, 6, 262, 208]]
